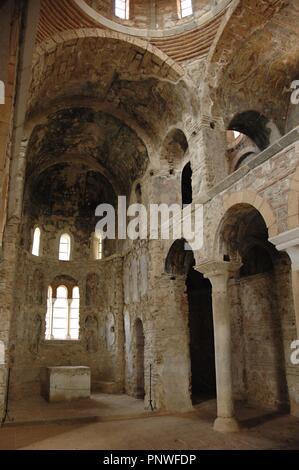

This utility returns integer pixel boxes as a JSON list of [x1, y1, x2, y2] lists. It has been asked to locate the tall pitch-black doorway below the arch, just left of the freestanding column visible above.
[[186, 268, 216, 404]]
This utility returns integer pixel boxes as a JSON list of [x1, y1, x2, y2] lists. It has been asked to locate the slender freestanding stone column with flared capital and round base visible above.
[[195, 261, 240, 432]]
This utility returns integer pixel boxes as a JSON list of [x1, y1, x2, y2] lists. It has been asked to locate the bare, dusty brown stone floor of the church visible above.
[[0, 395, 299, 450]]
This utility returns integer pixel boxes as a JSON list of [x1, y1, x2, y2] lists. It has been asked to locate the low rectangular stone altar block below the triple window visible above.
[[41, 366, 90, 402]]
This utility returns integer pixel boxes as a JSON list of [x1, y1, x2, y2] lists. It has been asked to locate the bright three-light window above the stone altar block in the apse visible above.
[[46, 286, 80, 340]]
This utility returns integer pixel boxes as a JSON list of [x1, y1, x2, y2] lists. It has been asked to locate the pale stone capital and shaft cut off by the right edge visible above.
[[269, 227, 299, 338]]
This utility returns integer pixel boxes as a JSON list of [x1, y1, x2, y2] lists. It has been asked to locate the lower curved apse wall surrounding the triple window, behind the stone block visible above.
[[10, 251, 124, 398]]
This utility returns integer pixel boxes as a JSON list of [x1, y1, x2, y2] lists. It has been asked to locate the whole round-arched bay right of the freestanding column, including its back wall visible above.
[[217, 202, 293, 409]]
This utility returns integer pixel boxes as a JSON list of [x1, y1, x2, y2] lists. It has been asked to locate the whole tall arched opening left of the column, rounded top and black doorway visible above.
[[165, 239, 216, 404]]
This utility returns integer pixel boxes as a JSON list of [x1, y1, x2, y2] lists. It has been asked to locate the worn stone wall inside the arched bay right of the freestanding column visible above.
[[229, 257, 298, 409]]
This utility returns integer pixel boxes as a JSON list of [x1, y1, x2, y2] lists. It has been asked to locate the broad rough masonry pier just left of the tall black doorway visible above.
[[149, 273, 192, 412]]
